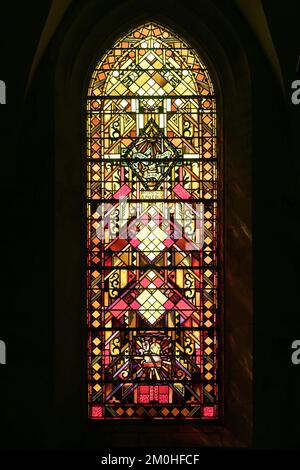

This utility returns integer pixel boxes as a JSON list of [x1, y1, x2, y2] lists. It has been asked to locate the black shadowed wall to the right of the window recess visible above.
[[254, 0, 300, 448]]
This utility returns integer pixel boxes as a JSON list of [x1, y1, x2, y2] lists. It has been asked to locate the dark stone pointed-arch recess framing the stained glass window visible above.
[[55, 0, 256, 445]]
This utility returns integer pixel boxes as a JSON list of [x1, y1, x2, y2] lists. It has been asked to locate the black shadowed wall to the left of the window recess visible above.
[[0, 0, 53, 448]]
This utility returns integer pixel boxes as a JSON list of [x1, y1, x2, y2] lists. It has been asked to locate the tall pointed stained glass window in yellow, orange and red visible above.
[[87, 22, 220, 420]]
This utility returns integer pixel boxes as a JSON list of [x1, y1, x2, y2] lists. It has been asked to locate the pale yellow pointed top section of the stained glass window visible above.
[[89, 22, 213, 100]]
